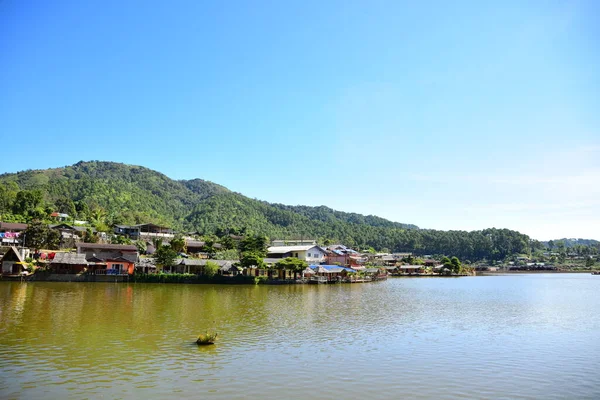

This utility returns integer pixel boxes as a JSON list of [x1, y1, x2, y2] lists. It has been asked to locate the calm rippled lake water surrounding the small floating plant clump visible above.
[[0, 274, 600, 399]]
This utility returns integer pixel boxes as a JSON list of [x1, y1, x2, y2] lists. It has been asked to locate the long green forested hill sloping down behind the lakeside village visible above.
[[0, 161, 541, 260]]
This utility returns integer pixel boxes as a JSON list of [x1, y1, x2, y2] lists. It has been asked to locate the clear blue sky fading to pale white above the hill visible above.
[[0, 0, 600, 239]]
